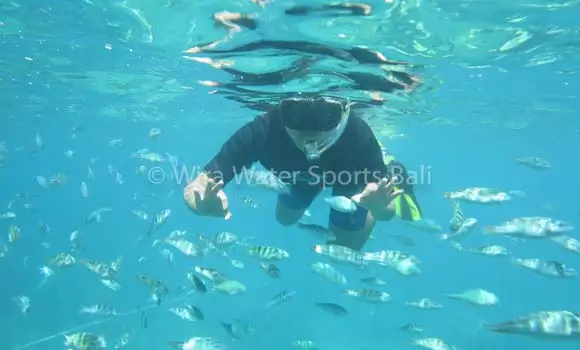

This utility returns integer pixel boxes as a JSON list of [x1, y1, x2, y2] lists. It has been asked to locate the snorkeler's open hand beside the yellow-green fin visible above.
[[351, 177, 403, 220]]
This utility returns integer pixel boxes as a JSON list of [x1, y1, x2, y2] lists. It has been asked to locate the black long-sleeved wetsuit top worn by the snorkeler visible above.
[[204, 109, 412, 196]]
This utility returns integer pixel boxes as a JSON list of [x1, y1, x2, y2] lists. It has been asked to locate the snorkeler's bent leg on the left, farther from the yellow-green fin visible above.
[[276, 185, 321, 226]]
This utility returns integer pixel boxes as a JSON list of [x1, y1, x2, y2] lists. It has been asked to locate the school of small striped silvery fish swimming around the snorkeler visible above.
[[0, 133, 580, 350]]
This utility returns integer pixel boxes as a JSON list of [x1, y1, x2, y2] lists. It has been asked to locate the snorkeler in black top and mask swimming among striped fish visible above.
[[184, 95, 421, 250]]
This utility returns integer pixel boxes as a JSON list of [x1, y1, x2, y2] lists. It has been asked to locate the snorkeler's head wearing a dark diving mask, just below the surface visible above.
[[278, 96, 350, 160]]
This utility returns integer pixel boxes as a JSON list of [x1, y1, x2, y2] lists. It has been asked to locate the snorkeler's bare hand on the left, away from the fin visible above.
[[183, 173, 232, 220]]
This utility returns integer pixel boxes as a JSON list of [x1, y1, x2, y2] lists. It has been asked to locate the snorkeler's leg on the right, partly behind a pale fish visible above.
[[328, 186, 375, 250]]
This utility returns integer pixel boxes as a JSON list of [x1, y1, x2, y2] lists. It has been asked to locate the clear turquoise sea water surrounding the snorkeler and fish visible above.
[[0, 1, 580, 350]]
